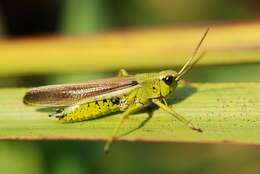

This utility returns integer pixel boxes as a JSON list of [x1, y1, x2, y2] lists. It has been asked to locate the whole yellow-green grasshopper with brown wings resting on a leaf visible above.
[[23, 29, 209, 152]]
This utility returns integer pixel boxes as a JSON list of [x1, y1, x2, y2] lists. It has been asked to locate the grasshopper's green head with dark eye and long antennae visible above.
[[160, 28, 209, 97]]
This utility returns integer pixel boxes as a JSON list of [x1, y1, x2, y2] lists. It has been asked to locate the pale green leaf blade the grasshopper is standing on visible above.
[[0, 83, 260, 144]]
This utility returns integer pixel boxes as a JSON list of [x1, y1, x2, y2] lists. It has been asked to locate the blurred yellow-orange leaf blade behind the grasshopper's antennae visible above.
[[0, 23, 260, 75]]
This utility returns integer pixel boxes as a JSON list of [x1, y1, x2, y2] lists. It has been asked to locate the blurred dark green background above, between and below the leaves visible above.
[[0, 0, 260, 174]]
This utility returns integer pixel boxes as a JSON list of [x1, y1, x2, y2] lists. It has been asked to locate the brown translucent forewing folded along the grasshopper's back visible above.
[[23, 76, 138, 106]]
